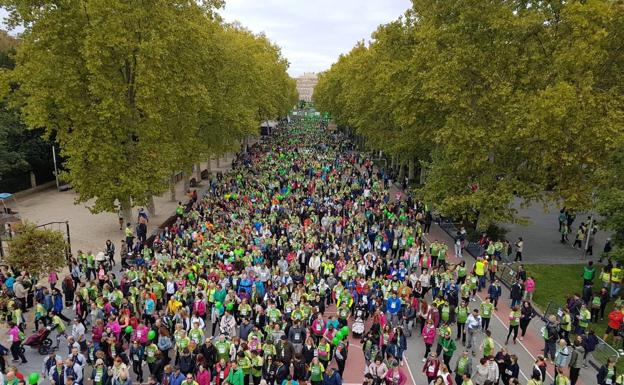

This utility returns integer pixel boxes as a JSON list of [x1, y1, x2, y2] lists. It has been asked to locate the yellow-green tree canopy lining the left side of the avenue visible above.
[[0, 0, 297, 212]]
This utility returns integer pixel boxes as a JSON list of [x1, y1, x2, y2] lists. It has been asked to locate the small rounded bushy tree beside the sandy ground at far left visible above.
[[5, 223, 67, 275]]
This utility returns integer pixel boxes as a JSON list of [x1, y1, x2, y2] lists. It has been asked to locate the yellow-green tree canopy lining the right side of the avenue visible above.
[[314, 0, 624, 234]]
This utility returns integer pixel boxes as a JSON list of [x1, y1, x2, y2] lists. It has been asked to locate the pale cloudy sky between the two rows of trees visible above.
[[219, 0, 411, 77]]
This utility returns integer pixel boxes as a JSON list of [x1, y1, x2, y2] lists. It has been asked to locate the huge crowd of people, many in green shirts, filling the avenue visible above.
[[1, 116, 621, 385]]
